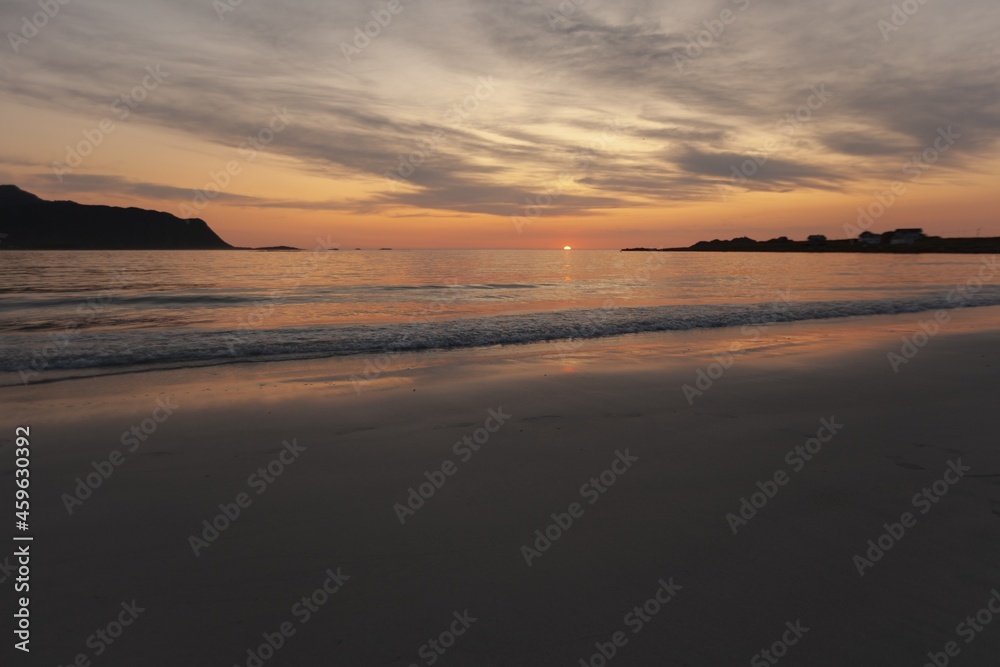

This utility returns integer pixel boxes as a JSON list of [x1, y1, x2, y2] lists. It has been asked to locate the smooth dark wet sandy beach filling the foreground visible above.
[[0, 308, 1000, 667]]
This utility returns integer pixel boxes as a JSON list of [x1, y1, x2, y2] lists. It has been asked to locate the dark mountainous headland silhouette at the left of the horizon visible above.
[[0, 185, 232, 250]]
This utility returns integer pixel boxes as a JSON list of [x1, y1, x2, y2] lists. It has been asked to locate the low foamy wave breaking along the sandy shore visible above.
[[0, 289, 1000, 380]]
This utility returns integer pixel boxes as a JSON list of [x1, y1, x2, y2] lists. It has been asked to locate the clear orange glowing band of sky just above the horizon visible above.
[[0, 96, 1000, 250]]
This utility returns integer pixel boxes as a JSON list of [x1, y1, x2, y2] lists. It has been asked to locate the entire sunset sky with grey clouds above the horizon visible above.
[[0, 0, 1000, 248]]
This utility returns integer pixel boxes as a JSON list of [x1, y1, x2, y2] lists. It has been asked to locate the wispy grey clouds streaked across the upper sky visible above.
[[0, 0, 1000, 216]]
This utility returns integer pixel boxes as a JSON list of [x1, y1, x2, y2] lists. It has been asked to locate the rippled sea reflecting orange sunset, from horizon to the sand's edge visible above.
[[0, 250, 1000, 383]]
